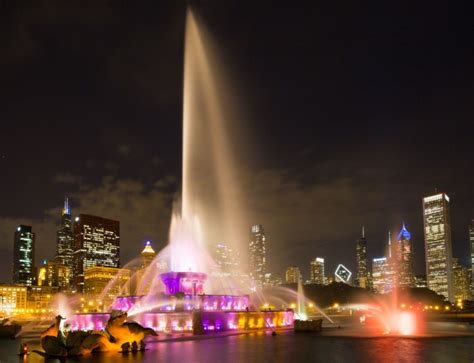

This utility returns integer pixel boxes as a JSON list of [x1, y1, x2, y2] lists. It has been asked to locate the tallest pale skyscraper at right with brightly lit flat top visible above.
[[423, 193, 454, 302]]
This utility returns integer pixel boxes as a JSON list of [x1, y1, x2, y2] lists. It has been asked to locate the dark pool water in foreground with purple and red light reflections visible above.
[[0, 332, 474, 363]]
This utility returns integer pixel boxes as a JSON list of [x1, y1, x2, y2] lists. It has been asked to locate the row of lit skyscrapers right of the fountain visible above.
[[249, 193, 474, 302]]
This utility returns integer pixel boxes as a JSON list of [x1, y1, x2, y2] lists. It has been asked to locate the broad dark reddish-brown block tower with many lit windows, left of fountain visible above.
[[73, 214, 120, 292]]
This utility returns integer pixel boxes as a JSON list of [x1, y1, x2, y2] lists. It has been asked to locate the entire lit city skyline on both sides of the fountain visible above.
[[6, 193, 474, 313]]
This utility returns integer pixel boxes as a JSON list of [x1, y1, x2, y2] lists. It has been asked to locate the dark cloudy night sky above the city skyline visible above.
[[0, 0, 474, 281]]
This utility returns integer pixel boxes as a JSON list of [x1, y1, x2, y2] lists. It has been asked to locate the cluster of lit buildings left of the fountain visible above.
[[0, 198, 129, 313]]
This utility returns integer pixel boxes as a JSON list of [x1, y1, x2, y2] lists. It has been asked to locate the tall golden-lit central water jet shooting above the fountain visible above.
[[181, 9, 242, 260]]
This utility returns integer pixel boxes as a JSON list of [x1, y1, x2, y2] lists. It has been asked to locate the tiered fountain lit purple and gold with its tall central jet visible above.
[[67, 10, 293, 334]]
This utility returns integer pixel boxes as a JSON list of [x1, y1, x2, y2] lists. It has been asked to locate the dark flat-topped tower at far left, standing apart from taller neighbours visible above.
[[13, 225, 36, 286]]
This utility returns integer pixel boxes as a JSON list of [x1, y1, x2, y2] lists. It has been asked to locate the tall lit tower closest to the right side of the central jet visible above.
[[249, 224, 266, 286]]
